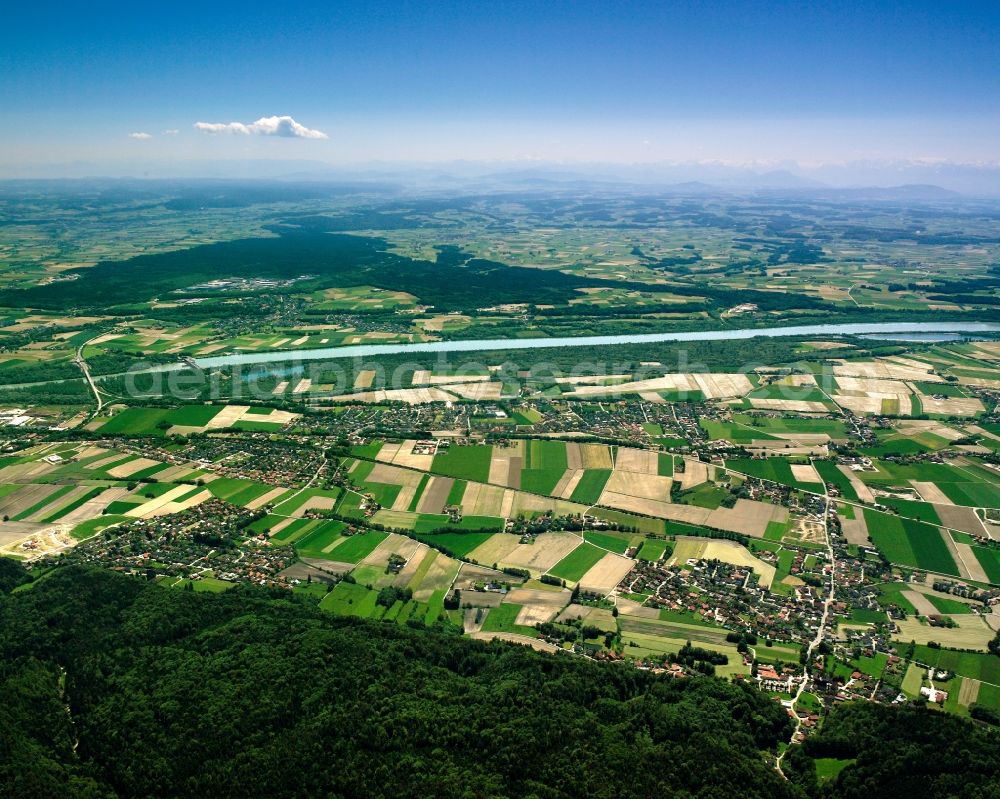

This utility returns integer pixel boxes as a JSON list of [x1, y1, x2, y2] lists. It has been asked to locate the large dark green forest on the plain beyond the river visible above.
[[0, 223, 836, 312]]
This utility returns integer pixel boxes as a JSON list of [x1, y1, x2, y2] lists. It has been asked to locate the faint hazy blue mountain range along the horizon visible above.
[[0, 160, 1000, 201]]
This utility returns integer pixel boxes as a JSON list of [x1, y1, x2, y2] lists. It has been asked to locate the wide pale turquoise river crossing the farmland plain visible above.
[[194, 322, 1000, 369]]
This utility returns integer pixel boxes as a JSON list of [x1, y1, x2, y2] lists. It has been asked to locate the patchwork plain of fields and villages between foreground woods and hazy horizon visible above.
[[0, 186, 1000, 764]]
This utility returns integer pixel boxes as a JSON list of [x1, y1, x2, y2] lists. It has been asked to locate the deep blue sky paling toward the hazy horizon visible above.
[[0, 0, 1000, 170]]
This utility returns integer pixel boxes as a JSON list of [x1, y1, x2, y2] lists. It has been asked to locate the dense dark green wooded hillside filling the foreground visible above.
[[0, 562, 1000, 799]]
